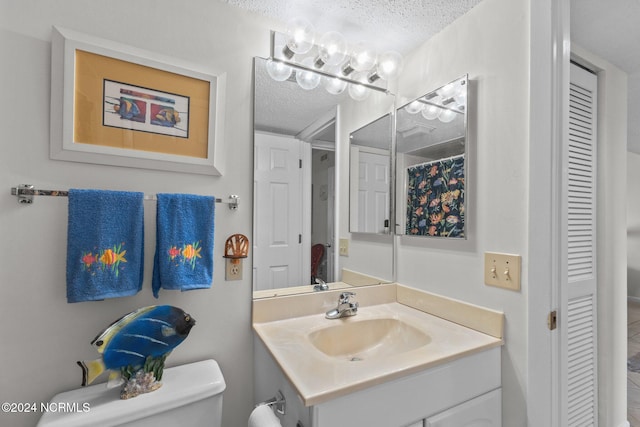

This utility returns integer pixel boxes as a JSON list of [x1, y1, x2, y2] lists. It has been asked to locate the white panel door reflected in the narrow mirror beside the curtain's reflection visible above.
[[358, 150, 390, 233]]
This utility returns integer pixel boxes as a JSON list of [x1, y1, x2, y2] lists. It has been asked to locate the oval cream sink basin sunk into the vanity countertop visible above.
[[308, 318, 431, 361]]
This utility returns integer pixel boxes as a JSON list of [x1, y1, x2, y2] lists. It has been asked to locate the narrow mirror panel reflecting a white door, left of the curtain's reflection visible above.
[[349, 114, 392, 234]]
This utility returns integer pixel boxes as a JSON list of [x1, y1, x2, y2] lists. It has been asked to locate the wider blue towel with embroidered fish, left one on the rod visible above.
[[67, 189, 144, 303]]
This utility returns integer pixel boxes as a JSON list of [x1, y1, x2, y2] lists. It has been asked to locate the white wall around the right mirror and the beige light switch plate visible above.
[[397, 0, 530, 427]]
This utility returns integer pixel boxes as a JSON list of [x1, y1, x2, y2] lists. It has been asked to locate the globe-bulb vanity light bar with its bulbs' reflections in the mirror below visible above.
[[267, 18, 403, 100]]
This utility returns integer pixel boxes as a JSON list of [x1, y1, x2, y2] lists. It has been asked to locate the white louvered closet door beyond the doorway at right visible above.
[[558, 64, 598, 427]]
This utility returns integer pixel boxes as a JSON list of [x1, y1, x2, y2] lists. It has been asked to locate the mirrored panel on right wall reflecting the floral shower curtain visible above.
[[396, 75, 469, 239]]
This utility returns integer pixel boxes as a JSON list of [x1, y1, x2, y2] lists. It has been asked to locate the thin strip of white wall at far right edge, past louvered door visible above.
[[627, 151, 640, 301]]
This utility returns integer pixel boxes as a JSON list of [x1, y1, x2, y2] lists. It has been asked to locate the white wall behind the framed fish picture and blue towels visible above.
[[0, 0, 274, 427]]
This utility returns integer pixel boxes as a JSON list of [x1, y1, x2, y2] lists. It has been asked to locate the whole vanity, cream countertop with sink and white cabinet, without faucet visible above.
[[253, 284, 504, 427]]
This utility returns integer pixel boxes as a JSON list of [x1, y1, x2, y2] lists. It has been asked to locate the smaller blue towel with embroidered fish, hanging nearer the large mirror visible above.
[[151, 194, 216, 298]]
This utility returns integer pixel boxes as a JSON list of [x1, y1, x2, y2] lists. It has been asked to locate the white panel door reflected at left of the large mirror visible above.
[[253, 133, 308, 291]]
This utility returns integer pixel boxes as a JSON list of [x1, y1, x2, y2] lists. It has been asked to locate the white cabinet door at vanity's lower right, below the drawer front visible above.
[[426, 389, 502, 427]]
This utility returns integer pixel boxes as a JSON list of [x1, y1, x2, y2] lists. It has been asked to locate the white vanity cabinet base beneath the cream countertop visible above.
[[256, 340, 502, 427]]
